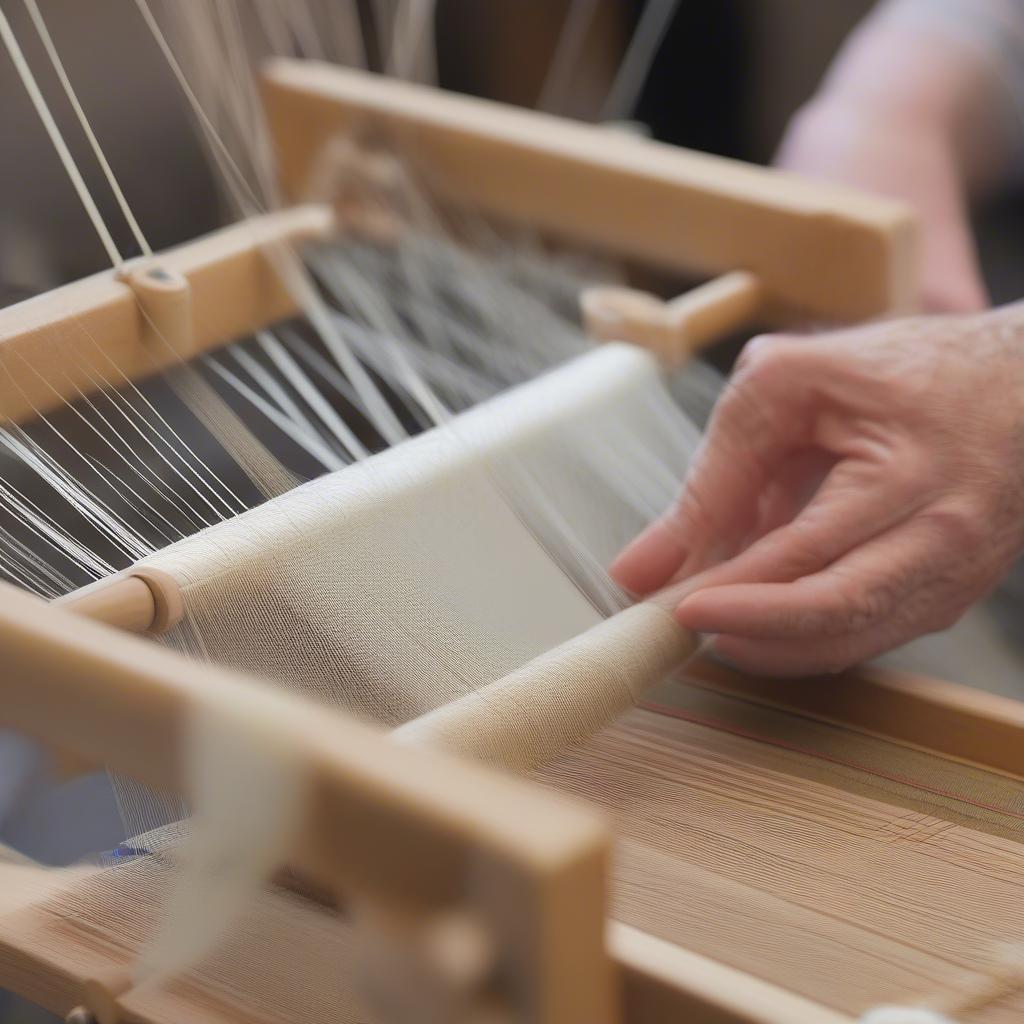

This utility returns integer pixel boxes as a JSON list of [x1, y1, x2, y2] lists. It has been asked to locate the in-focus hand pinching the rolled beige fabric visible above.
[[612, 305, 1024, 675]]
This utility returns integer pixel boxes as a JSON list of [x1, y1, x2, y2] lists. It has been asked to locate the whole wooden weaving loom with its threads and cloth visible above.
[[0, 12, 1024, 1024]]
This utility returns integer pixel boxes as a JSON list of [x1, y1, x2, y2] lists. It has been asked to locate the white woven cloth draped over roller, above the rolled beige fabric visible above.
[[146, 346, 696, 725]]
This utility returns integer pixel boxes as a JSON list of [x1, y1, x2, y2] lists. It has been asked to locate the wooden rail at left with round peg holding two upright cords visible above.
[[0, 206, 335, 423]]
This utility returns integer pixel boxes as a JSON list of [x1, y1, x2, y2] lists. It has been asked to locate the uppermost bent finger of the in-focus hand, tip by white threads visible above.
[[611, 339, 809, 595]]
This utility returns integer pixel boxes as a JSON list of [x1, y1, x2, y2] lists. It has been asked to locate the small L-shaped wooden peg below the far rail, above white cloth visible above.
[[580, 270, 763, 369]]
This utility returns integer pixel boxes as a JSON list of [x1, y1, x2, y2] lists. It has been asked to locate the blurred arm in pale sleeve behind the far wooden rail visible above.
[[776, 0, 1024, 311]]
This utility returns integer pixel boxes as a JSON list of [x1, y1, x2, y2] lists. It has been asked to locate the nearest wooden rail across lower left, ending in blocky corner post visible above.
[[0, 585, 617, 1024]]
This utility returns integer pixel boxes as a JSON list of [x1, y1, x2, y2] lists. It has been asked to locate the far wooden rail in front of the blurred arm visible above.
[[264, 59, 916, 322]]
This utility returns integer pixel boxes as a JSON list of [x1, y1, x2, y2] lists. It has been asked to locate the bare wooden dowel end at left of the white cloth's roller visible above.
[[54, 565, 184, 636]]
